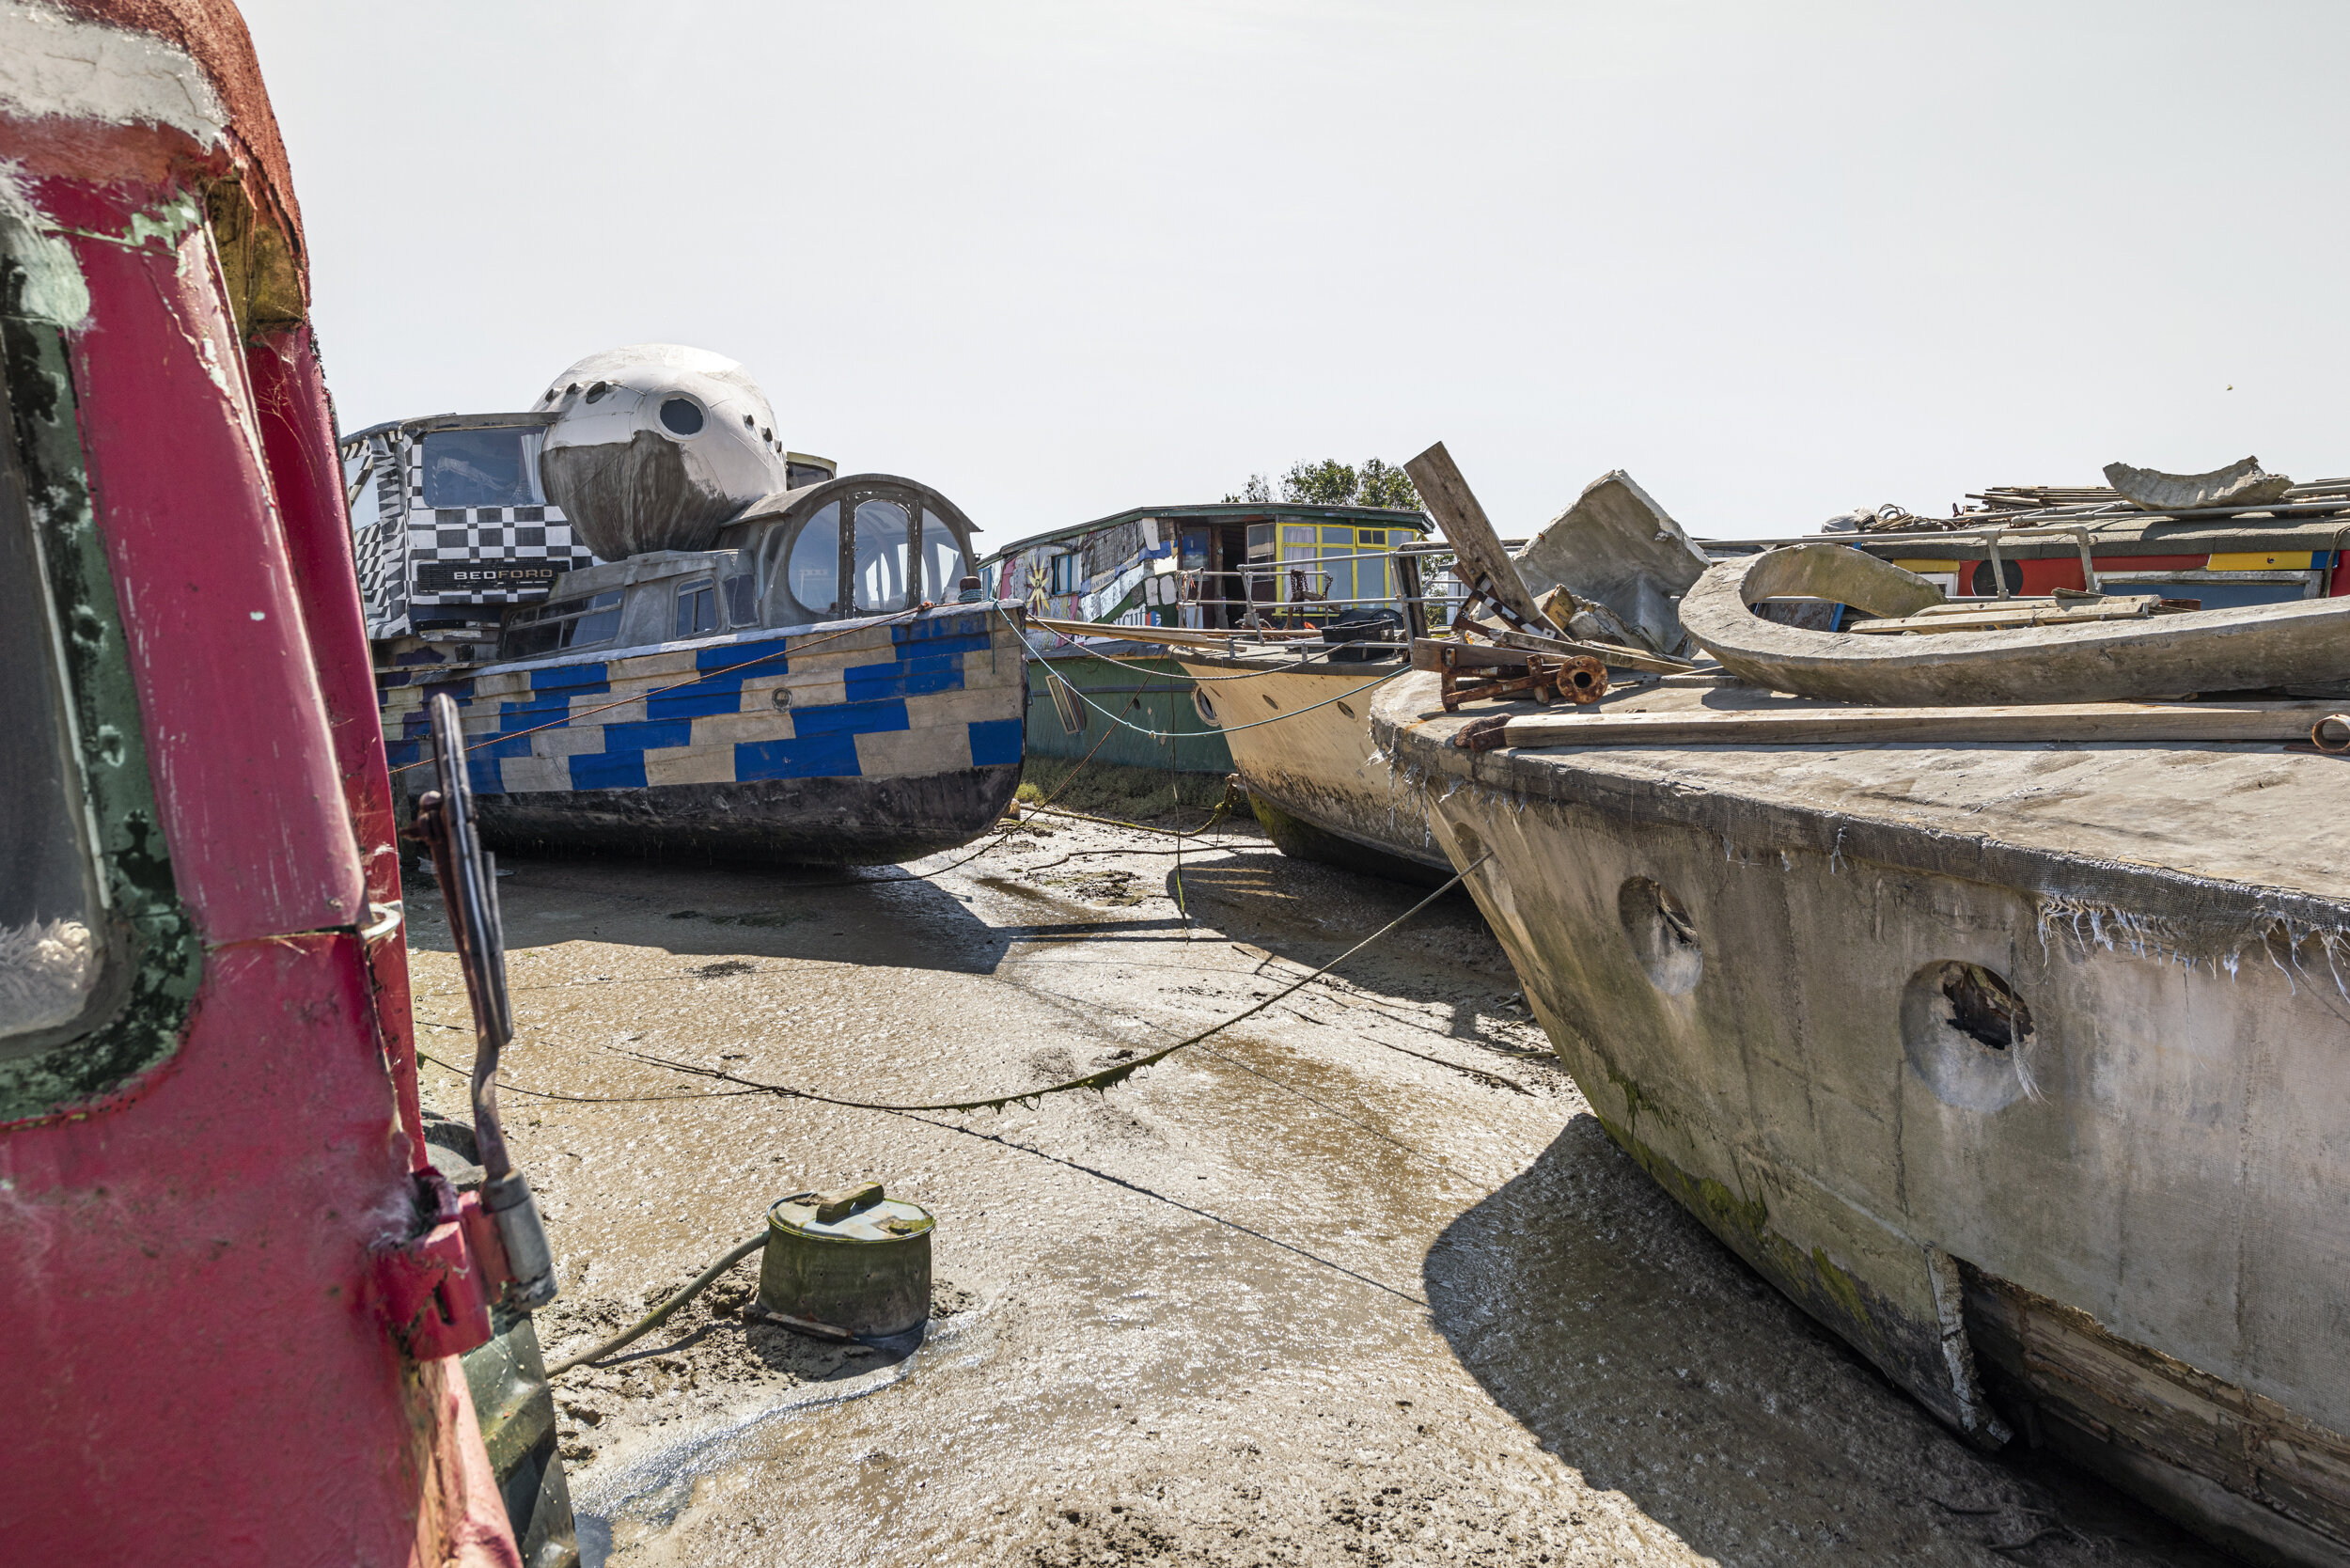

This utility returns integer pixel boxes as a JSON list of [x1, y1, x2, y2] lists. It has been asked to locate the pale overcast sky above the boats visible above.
[[244, 0, 2350, 548]]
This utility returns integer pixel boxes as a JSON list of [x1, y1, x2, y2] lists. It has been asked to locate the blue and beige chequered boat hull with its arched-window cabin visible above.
[[379, 475, 1027, 865]]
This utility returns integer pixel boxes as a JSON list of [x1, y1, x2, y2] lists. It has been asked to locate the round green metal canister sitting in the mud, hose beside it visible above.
[[760, 1183, 935, 1340]]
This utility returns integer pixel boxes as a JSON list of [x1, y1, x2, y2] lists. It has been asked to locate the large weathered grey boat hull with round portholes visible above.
[[1375, 677, 2350, 1563]]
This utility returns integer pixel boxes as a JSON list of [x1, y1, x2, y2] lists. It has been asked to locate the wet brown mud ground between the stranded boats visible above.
[[412, 818, 2218, 1568]]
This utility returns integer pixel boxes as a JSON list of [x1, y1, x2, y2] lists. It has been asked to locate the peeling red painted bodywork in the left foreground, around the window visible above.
[[0, 0, 520, 1568]]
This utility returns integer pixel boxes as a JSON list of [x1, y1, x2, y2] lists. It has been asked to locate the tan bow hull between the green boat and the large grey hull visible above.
[[1175, 651, 1452, 886]]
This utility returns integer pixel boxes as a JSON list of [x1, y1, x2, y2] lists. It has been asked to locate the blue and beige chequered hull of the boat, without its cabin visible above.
[[384, 604, 1027, 865]]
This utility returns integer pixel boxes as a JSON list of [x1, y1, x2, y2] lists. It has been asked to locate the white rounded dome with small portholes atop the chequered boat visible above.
[[539, 343, 788, 562]]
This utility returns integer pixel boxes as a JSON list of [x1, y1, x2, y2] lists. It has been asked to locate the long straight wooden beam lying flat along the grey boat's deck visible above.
[[1455, 703, 2331, 750]]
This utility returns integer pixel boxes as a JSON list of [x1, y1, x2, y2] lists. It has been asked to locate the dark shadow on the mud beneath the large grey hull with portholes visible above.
[[1422, 1114, 2223, 1565]]
